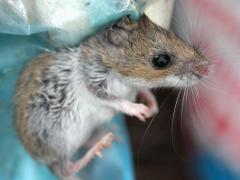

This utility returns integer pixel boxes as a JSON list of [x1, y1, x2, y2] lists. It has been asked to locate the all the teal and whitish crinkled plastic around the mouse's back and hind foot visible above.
[[0, 0, 143, 180]]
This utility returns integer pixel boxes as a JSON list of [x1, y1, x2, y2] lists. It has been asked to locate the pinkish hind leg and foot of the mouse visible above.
[[50, 133, 113, 180]]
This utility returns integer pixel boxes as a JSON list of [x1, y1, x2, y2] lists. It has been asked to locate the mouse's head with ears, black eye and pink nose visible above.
[[84, 16, 210, 87]]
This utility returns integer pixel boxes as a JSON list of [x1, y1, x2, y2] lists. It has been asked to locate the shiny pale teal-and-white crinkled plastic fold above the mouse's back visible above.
[[0, 0, 141, 45]]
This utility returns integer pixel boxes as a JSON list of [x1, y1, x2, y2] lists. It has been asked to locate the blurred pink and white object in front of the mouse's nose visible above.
[[178, 0, 240, 174]]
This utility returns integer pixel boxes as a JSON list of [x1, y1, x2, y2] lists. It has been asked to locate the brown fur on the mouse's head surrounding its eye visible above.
[[83, 16, 204, 82]]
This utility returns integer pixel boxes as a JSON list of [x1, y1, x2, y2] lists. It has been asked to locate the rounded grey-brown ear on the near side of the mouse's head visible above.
[[104, 26, 131, 48]]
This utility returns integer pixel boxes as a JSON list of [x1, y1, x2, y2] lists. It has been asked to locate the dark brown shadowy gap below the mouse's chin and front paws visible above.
[[126, 89, 191, 180]]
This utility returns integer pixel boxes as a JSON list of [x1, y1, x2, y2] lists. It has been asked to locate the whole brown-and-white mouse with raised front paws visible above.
[[14, 15, 211, 179]]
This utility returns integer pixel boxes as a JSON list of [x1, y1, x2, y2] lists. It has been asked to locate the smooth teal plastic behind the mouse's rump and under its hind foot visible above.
[[0, 34, 134, 180]]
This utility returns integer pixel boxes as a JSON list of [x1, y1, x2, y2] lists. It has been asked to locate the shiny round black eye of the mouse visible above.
[[151, 54, 172, 69]]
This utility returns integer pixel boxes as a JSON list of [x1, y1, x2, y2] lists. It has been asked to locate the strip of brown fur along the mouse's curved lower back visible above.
[[15, 54, 54, 156]]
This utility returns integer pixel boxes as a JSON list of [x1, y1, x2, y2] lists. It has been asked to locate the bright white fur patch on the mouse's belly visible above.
[[62, 93, 116, 153]]
